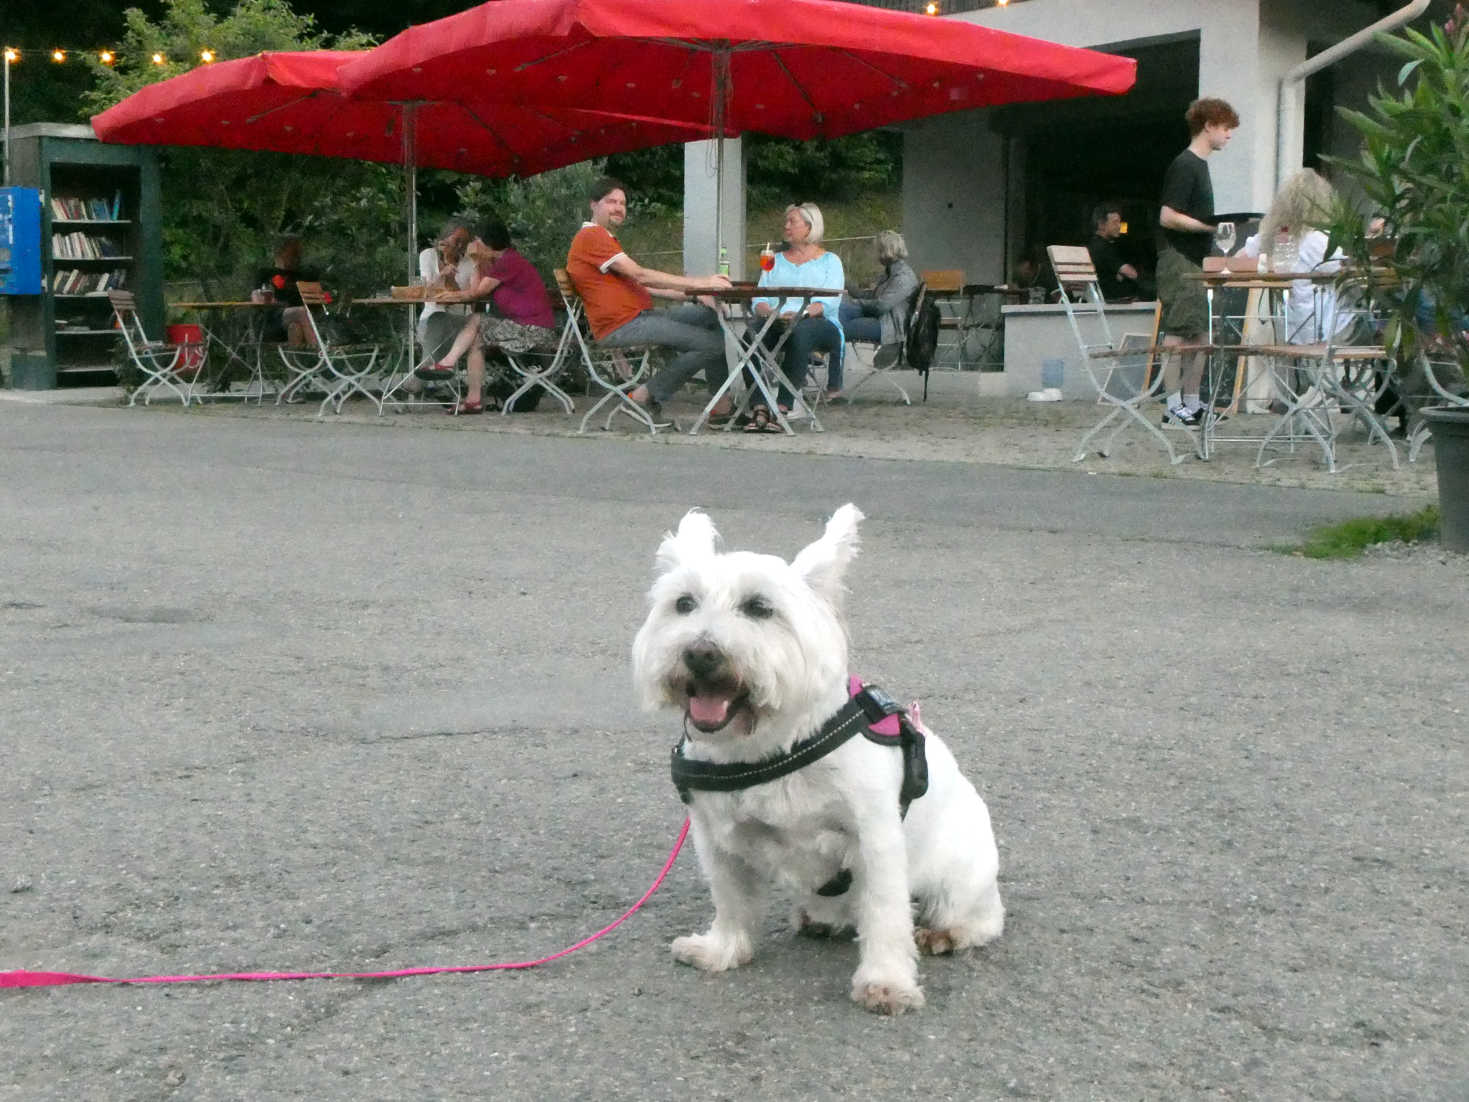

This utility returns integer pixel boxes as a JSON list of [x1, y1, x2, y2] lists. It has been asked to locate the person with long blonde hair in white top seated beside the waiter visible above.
[[1238, 169, 1371, 344]]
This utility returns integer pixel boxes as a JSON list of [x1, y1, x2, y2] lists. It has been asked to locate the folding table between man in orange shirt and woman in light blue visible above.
[[689, 284, 842, 436]]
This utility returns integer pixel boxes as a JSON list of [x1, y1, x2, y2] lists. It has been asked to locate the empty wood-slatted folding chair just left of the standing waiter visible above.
[[1046, 245, 1208, 463]]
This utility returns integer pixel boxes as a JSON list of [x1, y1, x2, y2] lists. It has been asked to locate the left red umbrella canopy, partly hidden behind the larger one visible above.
[[93, 50, 710, 176]]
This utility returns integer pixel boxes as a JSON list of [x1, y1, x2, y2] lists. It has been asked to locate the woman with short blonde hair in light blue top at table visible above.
[[745, 203, 846, 432]]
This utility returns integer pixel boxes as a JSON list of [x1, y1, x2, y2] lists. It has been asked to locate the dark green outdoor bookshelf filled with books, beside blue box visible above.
[[10, 123, 163, 386]]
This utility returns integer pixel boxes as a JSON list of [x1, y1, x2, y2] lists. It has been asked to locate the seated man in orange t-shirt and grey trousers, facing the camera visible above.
[[566, 176, 730, 417]]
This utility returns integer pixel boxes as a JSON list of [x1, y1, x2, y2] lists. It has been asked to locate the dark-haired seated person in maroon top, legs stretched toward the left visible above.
[[420, 222, 555, 413]]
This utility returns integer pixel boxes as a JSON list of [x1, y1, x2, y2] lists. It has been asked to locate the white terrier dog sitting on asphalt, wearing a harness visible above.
[[633, 504, 1005, 1014]]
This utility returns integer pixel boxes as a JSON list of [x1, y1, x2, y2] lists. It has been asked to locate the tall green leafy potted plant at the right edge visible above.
[[1332, 4, 1469, 551]]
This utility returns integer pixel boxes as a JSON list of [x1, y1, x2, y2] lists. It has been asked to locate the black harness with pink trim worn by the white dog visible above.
[[671, 679, 928, 815]]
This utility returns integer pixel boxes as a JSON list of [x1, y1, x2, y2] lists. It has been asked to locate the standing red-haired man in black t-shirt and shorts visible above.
[[1158, 98, 1240, 425]]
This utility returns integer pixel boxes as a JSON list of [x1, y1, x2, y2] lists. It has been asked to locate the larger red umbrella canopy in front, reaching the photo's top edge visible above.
[[342, 0, 1136, 138]]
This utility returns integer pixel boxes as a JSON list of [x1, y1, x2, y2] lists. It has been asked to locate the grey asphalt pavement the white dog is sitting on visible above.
[[0, 404, 1469, 1101]]
